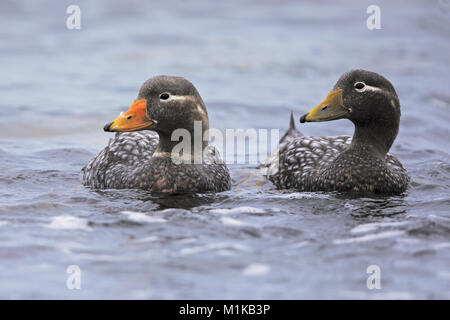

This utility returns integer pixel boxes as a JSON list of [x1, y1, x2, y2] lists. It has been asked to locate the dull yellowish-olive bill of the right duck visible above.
[[300, 89, 350, 123]]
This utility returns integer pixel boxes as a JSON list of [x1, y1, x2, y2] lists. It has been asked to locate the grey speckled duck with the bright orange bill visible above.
[[82, 75, 231, 193]]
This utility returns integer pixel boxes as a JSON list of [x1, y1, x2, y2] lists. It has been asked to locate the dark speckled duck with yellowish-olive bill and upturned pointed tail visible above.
[[264, 69, 410, 194]]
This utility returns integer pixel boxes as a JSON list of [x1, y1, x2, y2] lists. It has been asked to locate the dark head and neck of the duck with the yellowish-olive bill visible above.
[[300, 70, 401, 154]]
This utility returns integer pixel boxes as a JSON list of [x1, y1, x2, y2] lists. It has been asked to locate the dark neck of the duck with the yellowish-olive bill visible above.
[[349, 120, 399, 158]]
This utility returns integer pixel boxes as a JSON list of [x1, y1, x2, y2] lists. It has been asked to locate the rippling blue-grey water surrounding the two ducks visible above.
[[0, 0, 450, 299]]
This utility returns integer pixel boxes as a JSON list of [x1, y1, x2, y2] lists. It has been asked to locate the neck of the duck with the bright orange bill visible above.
[[155, 121, 209, 163]]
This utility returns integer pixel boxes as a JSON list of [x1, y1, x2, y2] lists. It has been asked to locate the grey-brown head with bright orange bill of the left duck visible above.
[[104, 76, 209, 149]]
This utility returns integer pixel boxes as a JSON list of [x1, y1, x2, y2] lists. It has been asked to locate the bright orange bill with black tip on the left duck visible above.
[[104, 99, 156, 132]]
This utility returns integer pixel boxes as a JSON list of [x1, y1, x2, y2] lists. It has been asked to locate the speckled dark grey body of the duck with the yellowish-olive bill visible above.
[[266, 134, 409, 193]]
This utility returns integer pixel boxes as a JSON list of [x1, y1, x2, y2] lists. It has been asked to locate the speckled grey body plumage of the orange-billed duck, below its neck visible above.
[[83, 131, 231, 192]]
